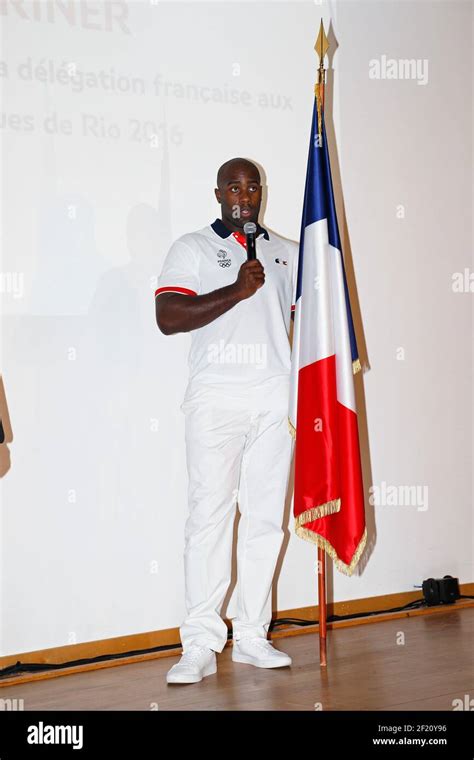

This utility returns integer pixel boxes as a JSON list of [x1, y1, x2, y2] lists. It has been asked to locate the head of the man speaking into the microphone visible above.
[[214, 158, 262, 231]]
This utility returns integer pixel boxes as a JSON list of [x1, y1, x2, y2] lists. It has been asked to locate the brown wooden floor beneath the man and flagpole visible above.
[[0, 608, 474, 710]]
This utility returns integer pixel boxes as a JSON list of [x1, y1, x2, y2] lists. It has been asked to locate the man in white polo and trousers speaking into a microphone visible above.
[[155, 158, 298, 683]]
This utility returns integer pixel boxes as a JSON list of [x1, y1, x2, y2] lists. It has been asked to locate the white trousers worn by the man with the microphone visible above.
[[180, 394, 293, 652]]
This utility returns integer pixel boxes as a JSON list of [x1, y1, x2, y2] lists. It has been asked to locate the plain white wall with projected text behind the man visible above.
[[0, 0, 474, 655]]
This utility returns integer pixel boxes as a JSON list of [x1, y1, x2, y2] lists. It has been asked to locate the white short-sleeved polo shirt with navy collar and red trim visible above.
[[155, 219, 299, 406]]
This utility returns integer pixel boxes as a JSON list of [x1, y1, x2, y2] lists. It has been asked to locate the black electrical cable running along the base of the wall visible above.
[[0, 595, 474, 680]]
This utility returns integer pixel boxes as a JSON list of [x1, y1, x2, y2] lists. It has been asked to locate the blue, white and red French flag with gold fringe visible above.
[[288, 98, 367, 575]]
